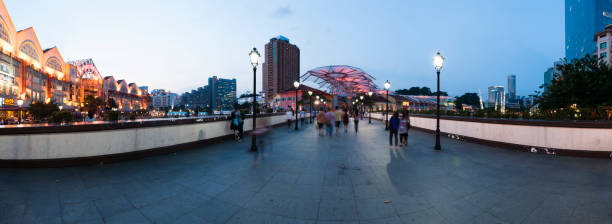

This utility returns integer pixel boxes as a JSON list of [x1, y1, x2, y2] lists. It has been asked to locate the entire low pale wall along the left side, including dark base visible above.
[[0, 114, 286, 166]]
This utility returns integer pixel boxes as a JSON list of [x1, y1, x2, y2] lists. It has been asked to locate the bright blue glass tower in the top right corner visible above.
[[565, 0, 612, 61]]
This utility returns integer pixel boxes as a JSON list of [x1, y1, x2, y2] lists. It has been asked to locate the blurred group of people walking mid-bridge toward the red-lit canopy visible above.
[[316, 107, 360, 136]]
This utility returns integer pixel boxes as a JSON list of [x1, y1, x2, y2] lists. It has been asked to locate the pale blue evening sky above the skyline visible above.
[[4, 0, 565, 95]]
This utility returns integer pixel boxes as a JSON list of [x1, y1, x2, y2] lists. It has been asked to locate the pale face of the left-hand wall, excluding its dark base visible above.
[[0, 115, 286, 160]]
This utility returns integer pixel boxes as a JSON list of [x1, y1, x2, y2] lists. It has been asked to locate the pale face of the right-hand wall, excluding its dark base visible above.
[[372, 114, 612, 152]]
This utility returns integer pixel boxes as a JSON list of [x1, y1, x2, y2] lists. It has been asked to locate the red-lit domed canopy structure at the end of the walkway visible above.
[[300, 65, 376, 96]]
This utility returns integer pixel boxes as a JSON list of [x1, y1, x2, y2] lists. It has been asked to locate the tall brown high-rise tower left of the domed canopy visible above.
[[262, 36, 300, 103]]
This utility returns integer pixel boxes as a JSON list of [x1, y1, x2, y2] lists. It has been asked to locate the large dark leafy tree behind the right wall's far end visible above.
[[536, 55, 612, 116]]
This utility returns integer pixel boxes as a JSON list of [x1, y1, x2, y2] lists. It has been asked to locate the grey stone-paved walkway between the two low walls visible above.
[[0, 120, 612, 224]]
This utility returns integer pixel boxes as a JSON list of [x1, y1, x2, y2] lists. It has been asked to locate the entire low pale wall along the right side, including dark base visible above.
[[372, 114, 612, 157]]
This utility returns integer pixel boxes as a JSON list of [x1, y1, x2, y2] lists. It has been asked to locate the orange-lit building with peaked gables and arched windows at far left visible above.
[[0, 0, 142, 119]]
